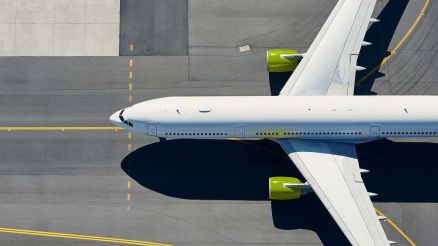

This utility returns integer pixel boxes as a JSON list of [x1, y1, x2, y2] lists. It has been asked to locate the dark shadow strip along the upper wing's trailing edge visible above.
[[355, 0, 409, 95]]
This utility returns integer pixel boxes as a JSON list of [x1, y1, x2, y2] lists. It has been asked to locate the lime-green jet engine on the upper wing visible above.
[[266, 49, 300, 73]]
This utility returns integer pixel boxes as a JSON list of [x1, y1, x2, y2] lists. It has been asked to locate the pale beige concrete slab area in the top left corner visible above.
[[0, 0, 120, 56]]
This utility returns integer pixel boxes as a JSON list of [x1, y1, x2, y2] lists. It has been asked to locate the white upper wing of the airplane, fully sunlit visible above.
[[280, 0, 377, 96]]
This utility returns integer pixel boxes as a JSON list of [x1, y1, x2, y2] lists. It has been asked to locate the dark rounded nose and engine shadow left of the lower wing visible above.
[[121, 140, 349, 245]]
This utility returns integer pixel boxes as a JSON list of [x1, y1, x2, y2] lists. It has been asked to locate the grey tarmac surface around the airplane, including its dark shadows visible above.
[[0, 0, 438, 246]]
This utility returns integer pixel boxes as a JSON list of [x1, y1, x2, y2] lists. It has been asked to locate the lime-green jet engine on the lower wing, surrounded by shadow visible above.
[[269, 177, 312, 200]]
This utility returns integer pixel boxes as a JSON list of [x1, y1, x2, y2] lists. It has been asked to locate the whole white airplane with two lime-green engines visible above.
[[110, 0, 432, 246]]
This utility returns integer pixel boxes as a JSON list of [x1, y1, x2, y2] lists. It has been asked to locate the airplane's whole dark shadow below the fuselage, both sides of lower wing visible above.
[[121, 137, 438, 245]]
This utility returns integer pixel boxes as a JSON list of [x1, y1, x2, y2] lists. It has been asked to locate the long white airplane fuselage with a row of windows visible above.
[[110, 96, 438, 143]]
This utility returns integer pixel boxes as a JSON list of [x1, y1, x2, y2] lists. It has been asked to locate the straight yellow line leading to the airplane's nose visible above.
[[0, 126, 123, 131]]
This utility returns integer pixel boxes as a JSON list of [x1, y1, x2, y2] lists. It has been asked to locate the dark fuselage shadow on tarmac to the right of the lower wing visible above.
[[357, 140, 438, 203]]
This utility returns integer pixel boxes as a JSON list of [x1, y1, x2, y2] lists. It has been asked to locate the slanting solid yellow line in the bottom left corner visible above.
[[0, 228, 171, 246]]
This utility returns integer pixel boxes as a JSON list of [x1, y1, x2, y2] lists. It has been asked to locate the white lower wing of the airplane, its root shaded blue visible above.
[[277, 139, 391, 246]]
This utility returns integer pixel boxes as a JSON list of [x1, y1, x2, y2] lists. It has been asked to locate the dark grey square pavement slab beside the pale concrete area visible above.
[[120, 0, 188, 56]]
